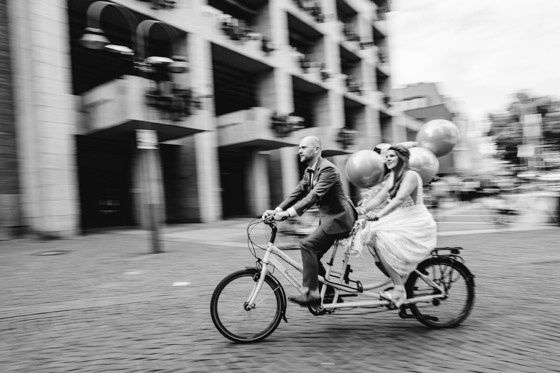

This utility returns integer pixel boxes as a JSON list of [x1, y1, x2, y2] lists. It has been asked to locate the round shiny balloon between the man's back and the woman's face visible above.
[[346, 150, 385, 188]]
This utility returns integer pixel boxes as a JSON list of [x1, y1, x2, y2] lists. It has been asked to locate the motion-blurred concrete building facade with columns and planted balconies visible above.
[[0, 0, 400, 236]]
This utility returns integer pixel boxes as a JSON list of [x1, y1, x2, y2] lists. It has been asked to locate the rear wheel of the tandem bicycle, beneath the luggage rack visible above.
[[406, 257, 475, 328]]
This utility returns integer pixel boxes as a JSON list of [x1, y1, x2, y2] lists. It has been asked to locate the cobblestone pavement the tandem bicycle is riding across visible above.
[[0, 220, 560, 373]]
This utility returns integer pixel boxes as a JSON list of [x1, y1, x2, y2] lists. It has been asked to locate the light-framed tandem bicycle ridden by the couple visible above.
[[210, 218, 475, 343]]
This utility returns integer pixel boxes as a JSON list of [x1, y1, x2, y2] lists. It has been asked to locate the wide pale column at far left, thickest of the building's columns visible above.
[[8, 0, 79, 236]]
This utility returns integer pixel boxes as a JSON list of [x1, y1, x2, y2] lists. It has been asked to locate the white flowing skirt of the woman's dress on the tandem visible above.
[[362, 204, 437, 276]]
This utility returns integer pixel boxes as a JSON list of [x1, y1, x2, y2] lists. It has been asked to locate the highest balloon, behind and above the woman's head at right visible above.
[[416, 119, 459, 157]]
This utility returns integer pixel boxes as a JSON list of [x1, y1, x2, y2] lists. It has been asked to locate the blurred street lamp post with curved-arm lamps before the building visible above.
[[80, 1, 188, 253]]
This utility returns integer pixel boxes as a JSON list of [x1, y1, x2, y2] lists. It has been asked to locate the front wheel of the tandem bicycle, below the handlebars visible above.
[[210, 268, 286, 343]]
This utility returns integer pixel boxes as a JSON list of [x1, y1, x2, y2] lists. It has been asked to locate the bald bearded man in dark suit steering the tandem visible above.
[[263, 136, 358, 306]]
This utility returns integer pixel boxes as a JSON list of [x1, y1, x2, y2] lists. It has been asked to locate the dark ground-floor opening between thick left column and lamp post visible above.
[[76, 136, 134, 233]]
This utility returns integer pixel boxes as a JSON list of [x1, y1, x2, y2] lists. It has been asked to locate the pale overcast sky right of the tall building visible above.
[[387, 0, 560, 122]]
